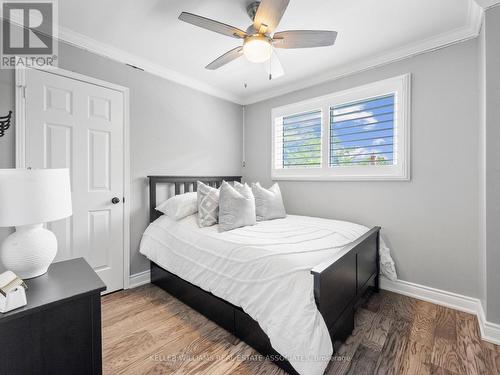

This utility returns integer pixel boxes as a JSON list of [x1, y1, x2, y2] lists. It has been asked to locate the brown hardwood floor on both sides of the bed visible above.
[[102, 285, 500, 375]]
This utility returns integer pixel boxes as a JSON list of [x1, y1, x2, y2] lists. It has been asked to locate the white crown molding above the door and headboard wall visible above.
[[58, 26, 242, 104]]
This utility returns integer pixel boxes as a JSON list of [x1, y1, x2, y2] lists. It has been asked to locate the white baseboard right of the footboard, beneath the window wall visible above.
[[380, 277, 500, 345]]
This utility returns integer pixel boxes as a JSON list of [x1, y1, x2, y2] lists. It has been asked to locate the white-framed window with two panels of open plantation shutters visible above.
[[272, 75, 410, 180]]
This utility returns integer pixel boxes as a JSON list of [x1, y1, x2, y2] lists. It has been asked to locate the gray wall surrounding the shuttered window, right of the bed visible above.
[[243, 39, 479, 297]]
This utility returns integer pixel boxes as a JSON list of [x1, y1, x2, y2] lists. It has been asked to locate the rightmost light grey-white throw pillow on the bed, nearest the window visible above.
[[252, 182, 286, 221]]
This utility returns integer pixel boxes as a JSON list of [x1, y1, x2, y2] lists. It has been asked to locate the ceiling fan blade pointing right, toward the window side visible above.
[[273, 30, 337, 48]]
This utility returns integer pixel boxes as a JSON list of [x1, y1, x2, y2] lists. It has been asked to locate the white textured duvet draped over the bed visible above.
[[140, 215, 395, 375]]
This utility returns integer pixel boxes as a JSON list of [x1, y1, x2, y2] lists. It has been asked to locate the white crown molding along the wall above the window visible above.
[[243, 0, 484, 105]]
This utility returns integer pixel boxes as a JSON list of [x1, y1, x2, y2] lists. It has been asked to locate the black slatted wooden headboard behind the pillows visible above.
[[148, 176, 241, 222]]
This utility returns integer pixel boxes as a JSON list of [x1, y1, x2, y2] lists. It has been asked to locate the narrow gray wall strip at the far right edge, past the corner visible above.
[[484, 6, 500, 323]]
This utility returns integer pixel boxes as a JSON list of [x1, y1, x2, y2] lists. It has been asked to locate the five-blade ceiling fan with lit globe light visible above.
[[179, 0, 337, 79]]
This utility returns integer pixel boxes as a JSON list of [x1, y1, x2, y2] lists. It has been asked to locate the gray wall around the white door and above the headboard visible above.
[[0, 38, 242, 274]]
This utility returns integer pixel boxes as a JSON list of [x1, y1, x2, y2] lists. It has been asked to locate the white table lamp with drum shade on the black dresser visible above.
[[0, 169, 72, 279]]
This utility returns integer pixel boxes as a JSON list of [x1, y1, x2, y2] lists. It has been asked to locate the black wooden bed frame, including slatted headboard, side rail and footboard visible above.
[[149, 176, 380, 375]]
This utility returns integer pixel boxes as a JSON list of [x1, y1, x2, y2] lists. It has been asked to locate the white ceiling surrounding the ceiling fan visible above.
[[59, 0, 478, 103]]
